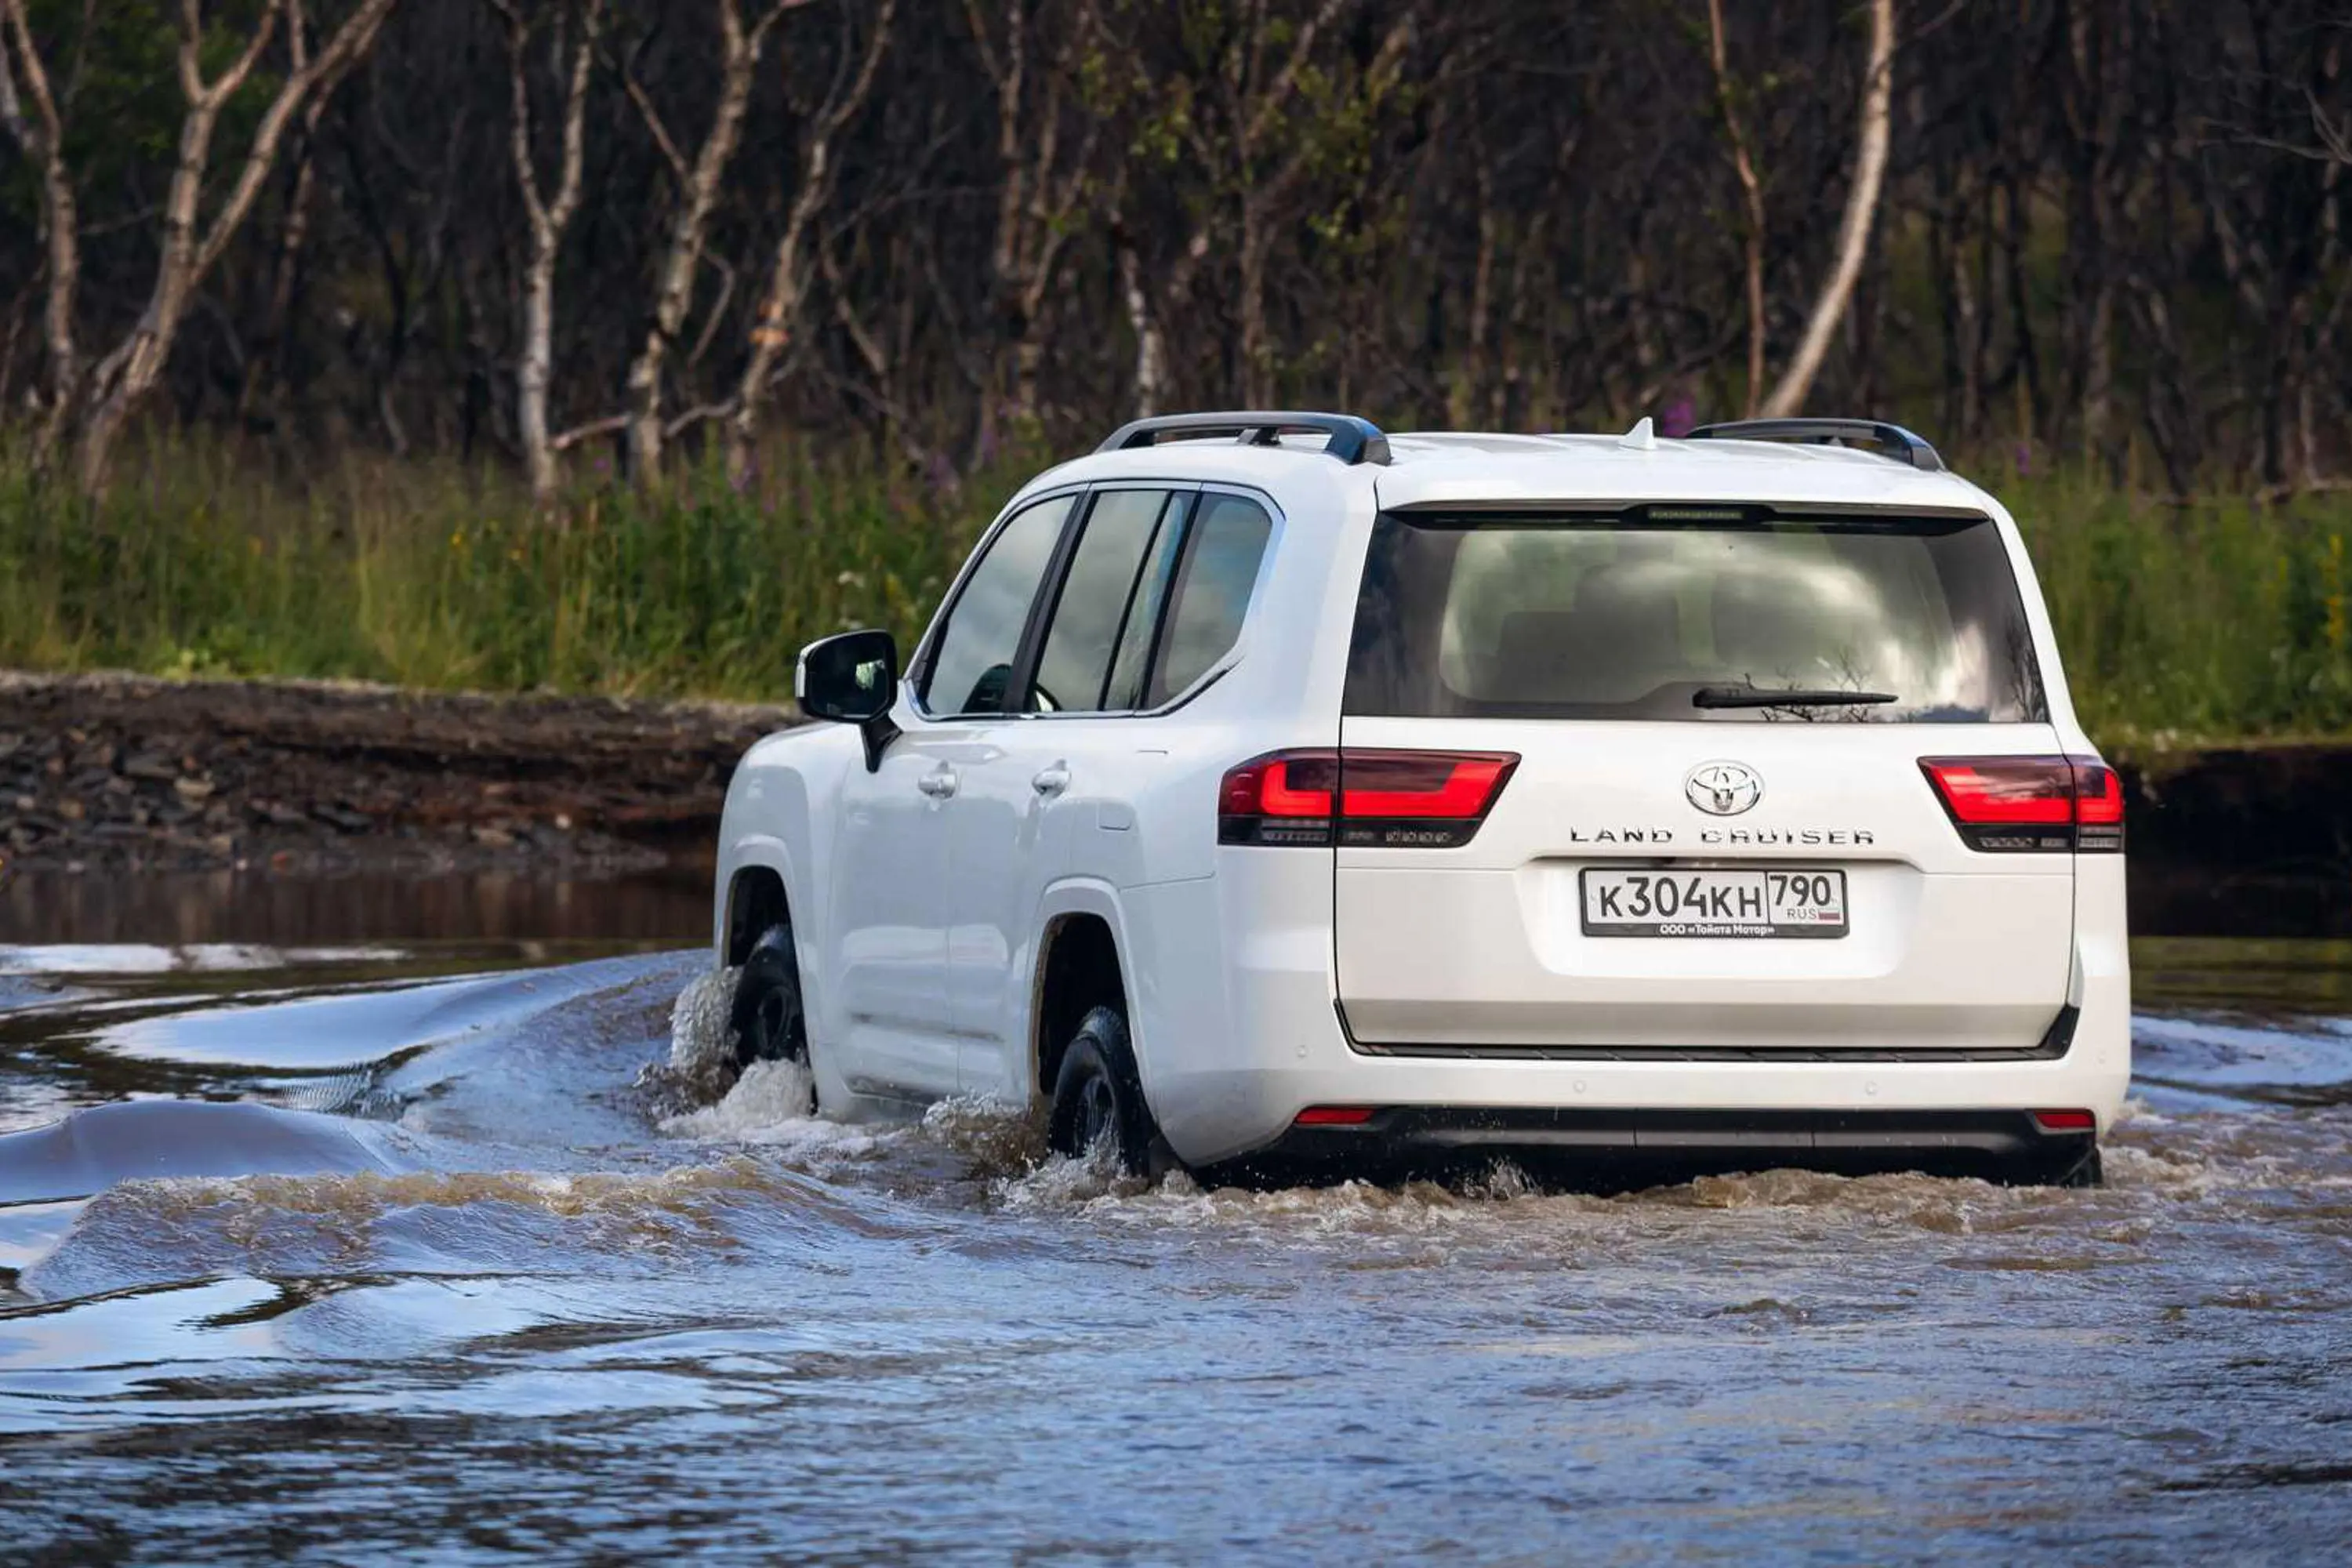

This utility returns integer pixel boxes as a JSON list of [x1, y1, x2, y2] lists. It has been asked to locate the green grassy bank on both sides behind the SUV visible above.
[[0, 432, 2352, 748]]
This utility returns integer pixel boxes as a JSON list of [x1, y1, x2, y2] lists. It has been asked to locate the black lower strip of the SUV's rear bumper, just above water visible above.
[[1216, 1105, 2096, 1182]]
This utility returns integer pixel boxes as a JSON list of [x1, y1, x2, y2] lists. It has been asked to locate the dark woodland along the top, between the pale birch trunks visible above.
[[0, 0, 2352, 492]]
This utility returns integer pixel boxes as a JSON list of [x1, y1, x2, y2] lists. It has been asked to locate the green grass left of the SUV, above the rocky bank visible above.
[[0, 430, 1035, 699]]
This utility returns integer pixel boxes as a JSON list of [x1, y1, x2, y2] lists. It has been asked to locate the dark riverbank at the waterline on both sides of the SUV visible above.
[[0, 673, 2352, 935]]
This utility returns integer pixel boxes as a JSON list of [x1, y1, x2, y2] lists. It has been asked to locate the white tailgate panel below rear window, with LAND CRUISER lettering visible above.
[[1336, 717, 2074, 1051]]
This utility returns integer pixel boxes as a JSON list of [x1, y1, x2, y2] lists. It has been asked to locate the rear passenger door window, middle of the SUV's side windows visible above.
[[1028, 489, 1183, 713]]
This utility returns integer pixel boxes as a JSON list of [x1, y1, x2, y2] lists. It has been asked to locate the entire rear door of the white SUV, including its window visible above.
[[1336, 508, 2074, 1051]]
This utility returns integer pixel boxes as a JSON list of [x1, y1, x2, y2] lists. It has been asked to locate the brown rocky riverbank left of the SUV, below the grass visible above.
[[0, 673, 797, 877]]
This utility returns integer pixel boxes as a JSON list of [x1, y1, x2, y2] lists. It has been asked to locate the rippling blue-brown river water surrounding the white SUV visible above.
[[0, 940, 2352, 1563]]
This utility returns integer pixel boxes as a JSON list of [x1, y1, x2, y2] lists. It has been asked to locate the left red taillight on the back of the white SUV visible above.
[[1216, 748, 1519, 848]]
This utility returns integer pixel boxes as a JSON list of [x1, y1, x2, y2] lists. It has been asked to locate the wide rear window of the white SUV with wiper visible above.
[[1345, 508, 2049, 724]]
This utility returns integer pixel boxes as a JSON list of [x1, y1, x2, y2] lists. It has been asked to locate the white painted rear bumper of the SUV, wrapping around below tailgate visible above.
[[1127, 851, 2131, 1168]]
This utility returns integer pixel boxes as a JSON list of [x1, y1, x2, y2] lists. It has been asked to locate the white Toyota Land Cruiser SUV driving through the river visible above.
[[715, 414, 2131, 1182]]
